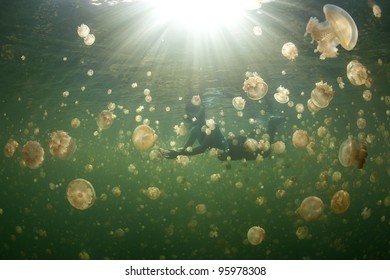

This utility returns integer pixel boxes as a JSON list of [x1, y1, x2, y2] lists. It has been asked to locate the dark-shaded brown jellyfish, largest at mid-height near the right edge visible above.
[[339, 139, 368, 169]]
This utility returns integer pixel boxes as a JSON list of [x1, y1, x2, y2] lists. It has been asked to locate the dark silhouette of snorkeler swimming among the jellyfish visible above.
[[160, 103, 285, 161]]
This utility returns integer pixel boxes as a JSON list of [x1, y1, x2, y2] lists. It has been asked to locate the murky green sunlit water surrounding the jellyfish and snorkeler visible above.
[[0, 0, 390, 259]]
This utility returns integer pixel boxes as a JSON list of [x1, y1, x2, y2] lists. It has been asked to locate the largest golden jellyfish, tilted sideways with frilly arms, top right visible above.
[[305, 4, 358, 59]]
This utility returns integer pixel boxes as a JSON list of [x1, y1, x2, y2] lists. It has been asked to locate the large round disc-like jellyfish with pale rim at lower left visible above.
[[66, 178, 96, 210]]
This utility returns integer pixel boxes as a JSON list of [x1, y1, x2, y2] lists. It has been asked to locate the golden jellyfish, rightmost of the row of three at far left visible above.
[[49, 130, 77, 159]]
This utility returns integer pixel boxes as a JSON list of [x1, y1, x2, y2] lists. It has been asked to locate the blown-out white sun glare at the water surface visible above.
[[151, 0, 250, 30]]
